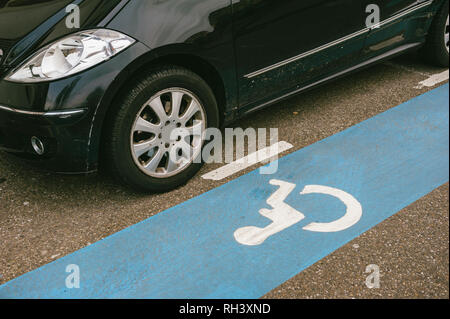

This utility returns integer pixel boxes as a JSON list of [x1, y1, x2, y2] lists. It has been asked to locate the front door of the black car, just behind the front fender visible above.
[[233, 0, 367, 112]]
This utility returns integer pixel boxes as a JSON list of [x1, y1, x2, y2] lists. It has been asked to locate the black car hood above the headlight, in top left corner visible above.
[[0, 0, 128, 68]]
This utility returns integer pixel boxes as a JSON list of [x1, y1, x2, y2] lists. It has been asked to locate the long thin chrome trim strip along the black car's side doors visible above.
[[244, 0, 433, 79]]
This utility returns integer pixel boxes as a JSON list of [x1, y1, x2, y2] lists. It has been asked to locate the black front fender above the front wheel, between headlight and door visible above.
[[107, 0, 238, 119]]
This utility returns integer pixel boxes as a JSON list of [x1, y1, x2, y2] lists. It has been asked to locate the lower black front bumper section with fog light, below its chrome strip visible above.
[[0, 105, 92, 173]]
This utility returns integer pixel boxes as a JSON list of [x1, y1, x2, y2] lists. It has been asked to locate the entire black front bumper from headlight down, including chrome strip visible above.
[[0, 42, 148, 173]]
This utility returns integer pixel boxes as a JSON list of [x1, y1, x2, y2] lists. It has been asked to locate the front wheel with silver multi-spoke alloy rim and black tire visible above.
[[103, 66, 219, 192]]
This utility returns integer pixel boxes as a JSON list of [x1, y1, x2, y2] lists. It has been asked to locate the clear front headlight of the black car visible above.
[[6, 29, 135, 83]]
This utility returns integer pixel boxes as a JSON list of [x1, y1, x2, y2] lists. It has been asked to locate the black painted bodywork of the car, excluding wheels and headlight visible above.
[[0, 0, 443, 172]]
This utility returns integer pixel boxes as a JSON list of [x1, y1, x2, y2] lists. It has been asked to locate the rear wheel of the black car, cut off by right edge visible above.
[[422, 1, 449, 67]]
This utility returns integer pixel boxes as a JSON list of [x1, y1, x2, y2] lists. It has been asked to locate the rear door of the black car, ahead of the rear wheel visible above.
[[363, 0, 432, 58]]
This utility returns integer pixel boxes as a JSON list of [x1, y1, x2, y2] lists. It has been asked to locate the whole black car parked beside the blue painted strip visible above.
[[0, 0, 449, 191]]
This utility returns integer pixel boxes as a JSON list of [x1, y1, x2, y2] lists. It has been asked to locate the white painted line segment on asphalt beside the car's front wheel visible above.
[[202, 141, 294, 181]]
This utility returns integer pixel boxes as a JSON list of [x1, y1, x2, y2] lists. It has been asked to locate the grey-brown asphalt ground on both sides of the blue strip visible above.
[[0, 54, 449, 298]]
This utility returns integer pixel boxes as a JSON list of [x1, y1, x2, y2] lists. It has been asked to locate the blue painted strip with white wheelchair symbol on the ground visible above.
[[0, 84, 449, 298]]
